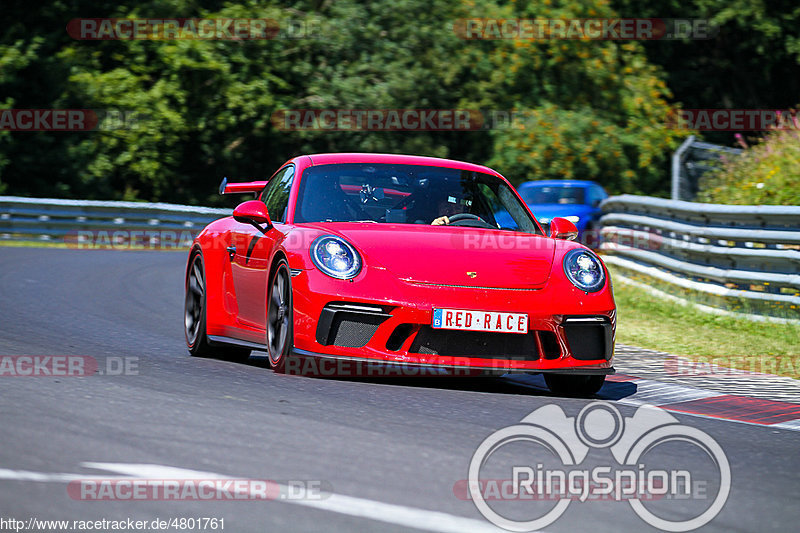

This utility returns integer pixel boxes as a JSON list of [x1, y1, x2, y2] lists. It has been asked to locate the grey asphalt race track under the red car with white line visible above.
[[0, 248, 800, 533]]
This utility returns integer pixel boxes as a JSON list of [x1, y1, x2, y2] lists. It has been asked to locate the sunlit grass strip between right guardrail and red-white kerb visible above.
[[611, 268, 800, 378]]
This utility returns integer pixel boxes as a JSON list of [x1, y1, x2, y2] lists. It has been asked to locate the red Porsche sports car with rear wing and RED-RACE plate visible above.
[[185, 154, 616, 395]]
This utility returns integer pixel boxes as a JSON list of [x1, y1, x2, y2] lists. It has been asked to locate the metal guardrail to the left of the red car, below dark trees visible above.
[[0, 196, 231, 247]]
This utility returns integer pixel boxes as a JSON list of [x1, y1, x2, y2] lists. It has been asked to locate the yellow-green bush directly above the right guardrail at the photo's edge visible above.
[[697, 130, 800, 205]]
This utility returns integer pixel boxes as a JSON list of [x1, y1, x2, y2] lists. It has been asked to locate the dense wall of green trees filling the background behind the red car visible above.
[[0, 0, 800, 204]]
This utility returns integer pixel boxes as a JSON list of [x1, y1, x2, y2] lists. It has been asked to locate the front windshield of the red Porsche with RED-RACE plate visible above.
[[294, 163, 540, 233]]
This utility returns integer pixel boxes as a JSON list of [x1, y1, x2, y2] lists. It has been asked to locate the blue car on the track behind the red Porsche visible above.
[[517, 180, 608, 245]]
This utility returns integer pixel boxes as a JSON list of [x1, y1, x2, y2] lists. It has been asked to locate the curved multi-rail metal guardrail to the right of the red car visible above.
[[600, 195, 800, 320]]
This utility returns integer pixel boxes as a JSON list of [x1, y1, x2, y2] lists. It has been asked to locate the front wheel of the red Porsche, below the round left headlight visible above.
[[267, 259, 294, 374]]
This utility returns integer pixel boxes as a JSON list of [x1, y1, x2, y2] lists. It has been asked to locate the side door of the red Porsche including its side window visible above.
[[229, 165, 294, 331]]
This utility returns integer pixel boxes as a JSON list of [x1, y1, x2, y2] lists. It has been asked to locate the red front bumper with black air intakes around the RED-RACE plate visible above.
[[292, 262, 616, 374]]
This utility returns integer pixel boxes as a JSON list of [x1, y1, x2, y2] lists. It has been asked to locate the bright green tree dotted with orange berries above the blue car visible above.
[[478, 2, 686, 194]]
